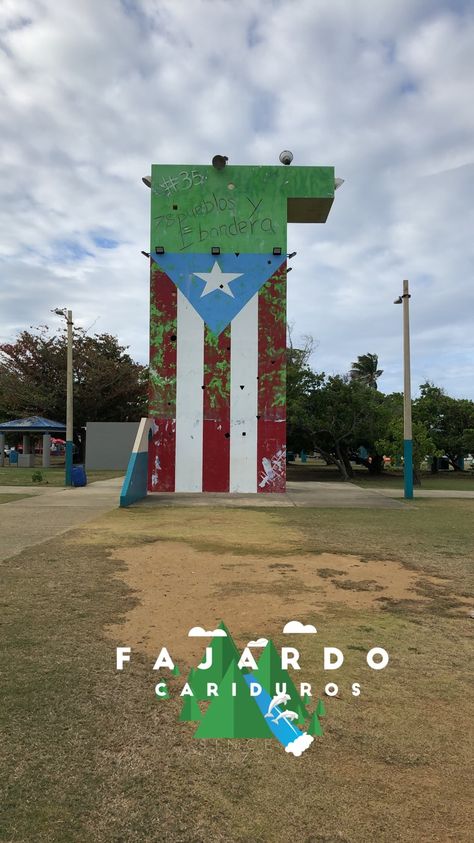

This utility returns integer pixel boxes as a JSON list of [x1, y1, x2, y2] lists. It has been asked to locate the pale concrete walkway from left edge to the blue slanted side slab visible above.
[[0, 477, 123, 560]]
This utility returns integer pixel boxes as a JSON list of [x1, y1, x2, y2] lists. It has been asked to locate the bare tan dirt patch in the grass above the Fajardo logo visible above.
[[107, 541, 445, 663]]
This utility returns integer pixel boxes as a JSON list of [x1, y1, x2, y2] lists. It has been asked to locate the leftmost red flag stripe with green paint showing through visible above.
[[148, 263, 177, 492]]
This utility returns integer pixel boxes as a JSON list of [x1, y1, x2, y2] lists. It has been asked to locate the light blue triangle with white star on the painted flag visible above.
[[150, 252, 282, 334]]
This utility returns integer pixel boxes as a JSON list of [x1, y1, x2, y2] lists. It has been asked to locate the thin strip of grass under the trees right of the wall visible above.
[[287, 462, 474, 492]]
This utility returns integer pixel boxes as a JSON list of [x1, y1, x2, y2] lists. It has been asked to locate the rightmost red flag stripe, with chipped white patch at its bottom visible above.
[[257, 261, 286, 492]]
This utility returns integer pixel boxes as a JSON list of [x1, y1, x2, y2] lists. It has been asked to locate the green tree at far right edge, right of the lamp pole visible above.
[[413, 382, 474, 471]]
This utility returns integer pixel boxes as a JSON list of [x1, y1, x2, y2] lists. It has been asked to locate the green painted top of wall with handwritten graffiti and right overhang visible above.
[[150, 164, 334, 254]]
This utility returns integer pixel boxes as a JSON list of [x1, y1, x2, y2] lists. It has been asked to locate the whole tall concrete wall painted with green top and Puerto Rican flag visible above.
[[148, 165, 334, 492]]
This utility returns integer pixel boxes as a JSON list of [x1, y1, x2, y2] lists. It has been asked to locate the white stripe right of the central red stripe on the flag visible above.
[[230, 294, 258, 492]]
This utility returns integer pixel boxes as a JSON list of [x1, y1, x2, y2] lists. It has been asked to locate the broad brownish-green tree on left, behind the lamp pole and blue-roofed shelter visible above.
[[0, 325, 147, 436]]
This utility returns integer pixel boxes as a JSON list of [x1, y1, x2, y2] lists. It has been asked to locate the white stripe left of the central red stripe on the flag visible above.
[[175, 290, 204, 492]]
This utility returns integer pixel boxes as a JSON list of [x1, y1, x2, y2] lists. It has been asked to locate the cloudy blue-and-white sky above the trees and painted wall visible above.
[[0, 0, 474, 398]]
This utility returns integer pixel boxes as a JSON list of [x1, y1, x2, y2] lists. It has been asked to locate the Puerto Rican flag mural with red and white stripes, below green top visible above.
[[148, 252, 286, 493]]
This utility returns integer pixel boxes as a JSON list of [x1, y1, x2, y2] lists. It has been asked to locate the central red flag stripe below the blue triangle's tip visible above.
[[202, 326, 231, 492]]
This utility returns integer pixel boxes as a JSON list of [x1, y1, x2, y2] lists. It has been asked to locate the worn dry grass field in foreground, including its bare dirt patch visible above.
[[0, 500, 474, 843]]
